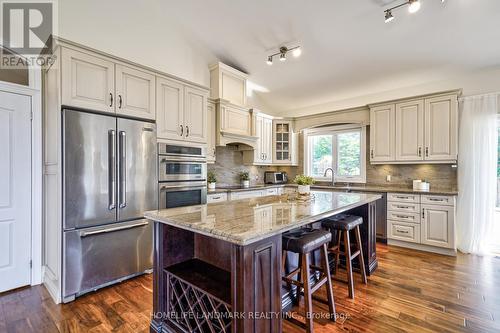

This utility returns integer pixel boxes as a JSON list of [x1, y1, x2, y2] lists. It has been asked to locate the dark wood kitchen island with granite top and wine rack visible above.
[[145, 191, 381, 332]]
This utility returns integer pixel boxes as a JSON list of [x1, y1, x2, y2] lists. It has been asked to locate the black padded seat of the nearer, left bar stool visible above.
[[282, 228, 332, 253]]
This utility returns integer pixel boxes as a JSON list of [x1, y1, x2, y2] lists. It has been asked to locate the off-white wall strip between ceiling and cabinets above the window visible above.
[[276, 68, 500, 117]]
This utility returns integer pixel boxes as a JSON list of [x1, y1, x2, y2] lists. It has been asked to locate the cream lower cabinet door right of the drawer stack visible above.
[[421, 205, 455, 249]]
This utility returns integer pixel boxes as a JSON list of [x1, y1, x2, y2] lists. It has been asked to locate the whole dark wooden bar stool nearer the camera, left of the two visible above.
[[282, 228, 336, 333]]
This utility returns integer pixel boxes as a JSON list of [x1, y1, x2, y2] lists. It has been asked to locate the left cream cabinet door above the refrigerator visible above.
[[61, 48, 116, 112]]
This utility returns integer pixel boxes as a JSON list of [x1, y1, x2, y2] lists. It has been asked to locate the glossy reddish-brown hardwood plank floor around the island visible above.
[[0, 245, 500, 333]]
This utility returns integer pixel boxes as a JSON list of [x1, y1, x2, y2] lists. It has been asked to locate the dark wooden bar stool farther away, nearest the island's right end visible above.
[[321, 214, 367, 299]]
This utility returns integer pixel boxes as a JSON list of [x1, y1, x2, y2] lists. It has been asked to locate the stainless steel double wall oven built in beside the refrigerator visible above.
[[158, 143, 207, 209]]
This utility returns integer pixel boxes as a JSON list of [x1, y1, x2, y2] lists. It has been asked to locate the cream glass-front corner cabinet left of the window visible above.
[[273, 119, 298, 165]]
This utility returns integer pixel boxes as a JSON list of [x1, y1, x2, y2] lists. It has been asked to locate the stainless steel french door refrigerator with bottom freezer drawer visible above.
[[62, 109, 158, 302]]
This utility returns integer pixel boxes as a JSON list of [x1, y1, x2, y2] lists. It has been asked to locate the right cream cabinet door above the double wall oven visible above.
[[184, 86, 207, 143]]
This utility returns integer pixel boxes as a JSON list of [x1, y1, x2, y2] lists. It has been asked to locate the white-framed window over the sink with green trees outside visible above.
[[304, 125, 366, 183]]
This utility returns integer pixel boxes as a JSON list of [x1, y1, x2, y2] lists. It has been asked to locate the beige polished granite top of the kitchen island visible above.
[[144, 190, 381, 245]]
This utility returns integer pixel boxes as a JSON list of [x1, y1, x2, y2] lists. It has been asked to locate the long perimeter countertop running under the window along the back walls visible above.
[[207, 184, 458, 196]]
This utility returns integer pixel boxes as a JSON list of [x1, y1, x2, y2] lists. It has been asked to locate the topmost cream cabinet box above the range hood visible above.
[[210, 62, 248, 106]]
